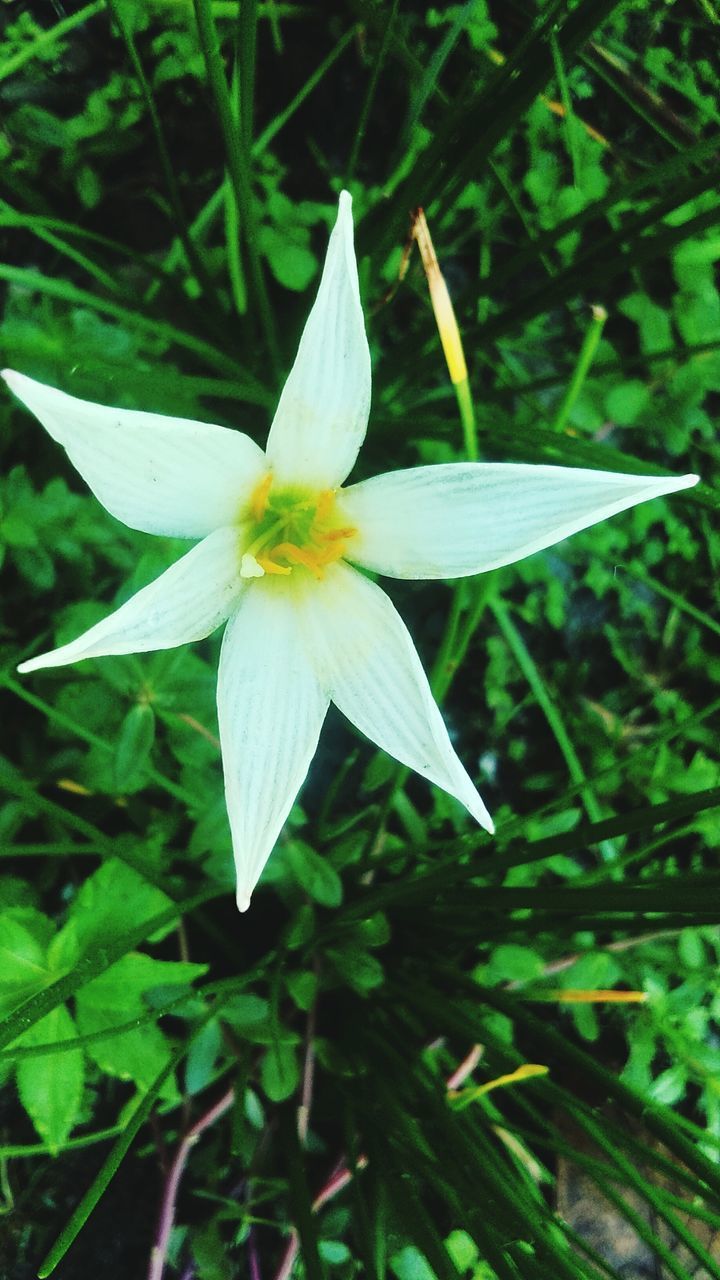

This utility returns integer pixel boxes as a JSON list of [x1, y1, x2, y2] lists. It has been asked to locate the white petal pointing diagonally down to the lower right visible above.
[[294, 564, 493, 832]]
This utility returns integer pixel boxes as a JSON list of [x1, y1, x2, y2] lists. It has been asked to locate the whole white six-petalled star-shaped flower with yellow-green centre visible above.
[[4, 192, 697, 911]]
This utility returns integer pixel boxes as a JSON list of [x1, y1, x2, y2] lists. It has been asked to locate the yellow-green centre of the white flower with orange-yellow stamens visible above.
[[240, 471, 355, 577]]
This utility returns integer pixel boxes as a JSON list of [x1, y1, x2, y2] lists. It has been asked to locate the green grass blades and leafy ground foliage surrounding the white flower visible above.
[[0, 0, 720, 1280]]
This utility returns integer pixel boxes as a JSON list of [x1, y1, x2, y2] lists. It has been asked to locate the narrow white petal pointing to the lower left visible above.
[[18, 529, 243, 673]]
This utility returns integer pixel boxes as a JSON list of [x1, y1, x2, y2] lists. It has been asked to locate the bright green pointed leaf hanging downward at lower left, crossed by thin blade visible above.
[[17, 1005, 85, 1153]]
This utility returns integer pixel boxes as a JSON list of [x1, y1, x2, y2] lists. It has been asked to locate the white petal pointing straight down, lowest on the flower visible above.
[[218, 581, 329, 911]]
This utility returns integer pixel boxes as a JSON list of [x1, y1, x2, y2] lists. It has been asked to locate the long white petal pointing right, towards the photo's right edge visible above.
[[338, 462, 698, 577]]
